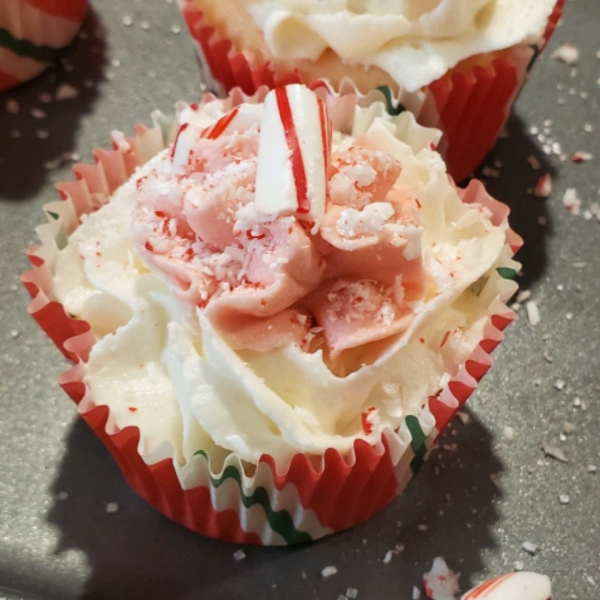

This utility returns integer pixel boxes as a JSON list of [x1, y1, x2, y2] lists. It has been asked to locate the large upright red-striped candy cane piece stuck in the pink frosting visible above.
[[255, 85, 331, 226]]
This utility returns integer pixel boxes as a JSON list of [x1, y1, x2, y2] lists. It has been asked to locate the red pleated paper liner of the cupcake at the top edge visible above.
[[179, 0, 565, 181]]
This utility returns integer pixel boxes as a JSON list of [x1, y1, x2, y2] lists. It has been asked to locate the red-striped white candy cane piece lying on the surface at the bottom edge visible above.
[[460, 571, 551, 600]]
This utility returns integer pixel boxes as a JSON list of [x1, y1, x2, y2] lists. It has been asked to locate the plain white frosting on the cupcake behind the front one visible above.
[[243, 0, 555, 92]]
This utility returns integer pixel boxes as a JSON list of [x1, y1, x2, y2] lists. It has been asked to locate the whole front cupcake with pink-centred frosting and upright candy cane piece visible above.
[[23, 85, 521, 544]]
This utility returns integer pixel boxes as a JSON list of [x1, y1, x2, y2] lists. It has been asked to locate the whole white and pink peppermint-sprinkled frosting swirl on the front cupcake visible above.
[[54, 88, 510, 468]]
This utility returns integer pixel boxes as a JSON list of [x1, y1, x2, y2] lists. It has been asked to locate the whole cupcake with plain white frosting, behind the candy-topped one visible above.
[[179, 0, 564, 181]]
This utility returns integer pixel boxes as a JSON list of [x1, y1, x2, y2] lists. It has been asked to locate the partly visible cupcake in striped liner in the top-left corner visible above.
[[0, 0, 88, 92]]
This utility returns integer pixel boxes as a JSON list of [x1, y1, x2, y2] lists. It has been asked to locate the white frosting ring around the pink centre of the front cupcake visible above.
[[54, 91, 510, 468]]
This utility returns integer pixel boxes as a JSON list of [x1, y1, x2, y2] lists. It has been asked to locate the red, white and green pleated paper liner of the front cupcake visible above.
[[22, 83, 521, 545]]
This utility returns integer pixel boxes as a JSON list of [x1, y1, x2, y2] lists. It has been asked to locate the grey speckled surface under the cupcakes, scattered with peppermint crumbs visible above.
[[0, 0, 600, 600]]
